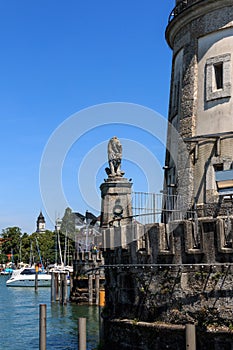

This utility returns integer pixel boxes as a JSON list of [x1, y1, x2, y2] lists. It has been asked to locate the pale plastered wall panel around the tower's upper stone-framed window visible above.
[[198, 27, 233, 135]]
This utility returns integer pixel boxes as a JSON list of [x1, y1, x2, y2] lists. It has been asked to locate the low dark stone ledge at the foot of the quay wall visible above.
[[104, 319, 233, 350]]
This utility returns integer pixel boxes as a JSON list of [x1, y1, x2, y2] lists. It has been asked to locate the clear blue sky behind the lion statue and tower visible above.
[[0, 0, 174, 233]]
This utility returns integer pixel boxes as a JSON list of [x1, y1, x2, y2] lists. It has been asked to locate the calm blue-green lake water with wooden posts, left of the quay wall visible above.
[[0, 275, 99, 350]]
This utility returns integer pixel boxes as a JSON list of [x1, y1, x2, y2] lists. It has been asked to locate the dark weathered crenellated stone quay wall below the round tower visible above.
[[102, 217, 233, 350]]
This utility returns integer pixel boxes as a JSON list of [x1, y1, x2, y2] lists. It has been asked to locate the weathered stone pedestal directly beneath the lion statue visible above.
[[100, 176, 132, 228]]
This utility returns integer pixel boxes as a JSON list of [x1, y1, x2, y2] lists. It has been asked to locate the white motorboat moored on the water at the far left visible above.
[[6, 267, 51, 287]]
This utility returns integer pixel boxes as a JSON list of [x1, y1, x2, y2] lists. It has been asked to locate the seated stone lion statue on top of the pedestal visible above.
[[105, 136, 124, 177]]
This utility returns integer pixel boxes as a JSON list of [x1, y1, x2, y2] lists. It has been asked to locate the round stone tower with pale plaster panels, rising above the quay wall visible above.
[[165, 0, 233, 217]]
